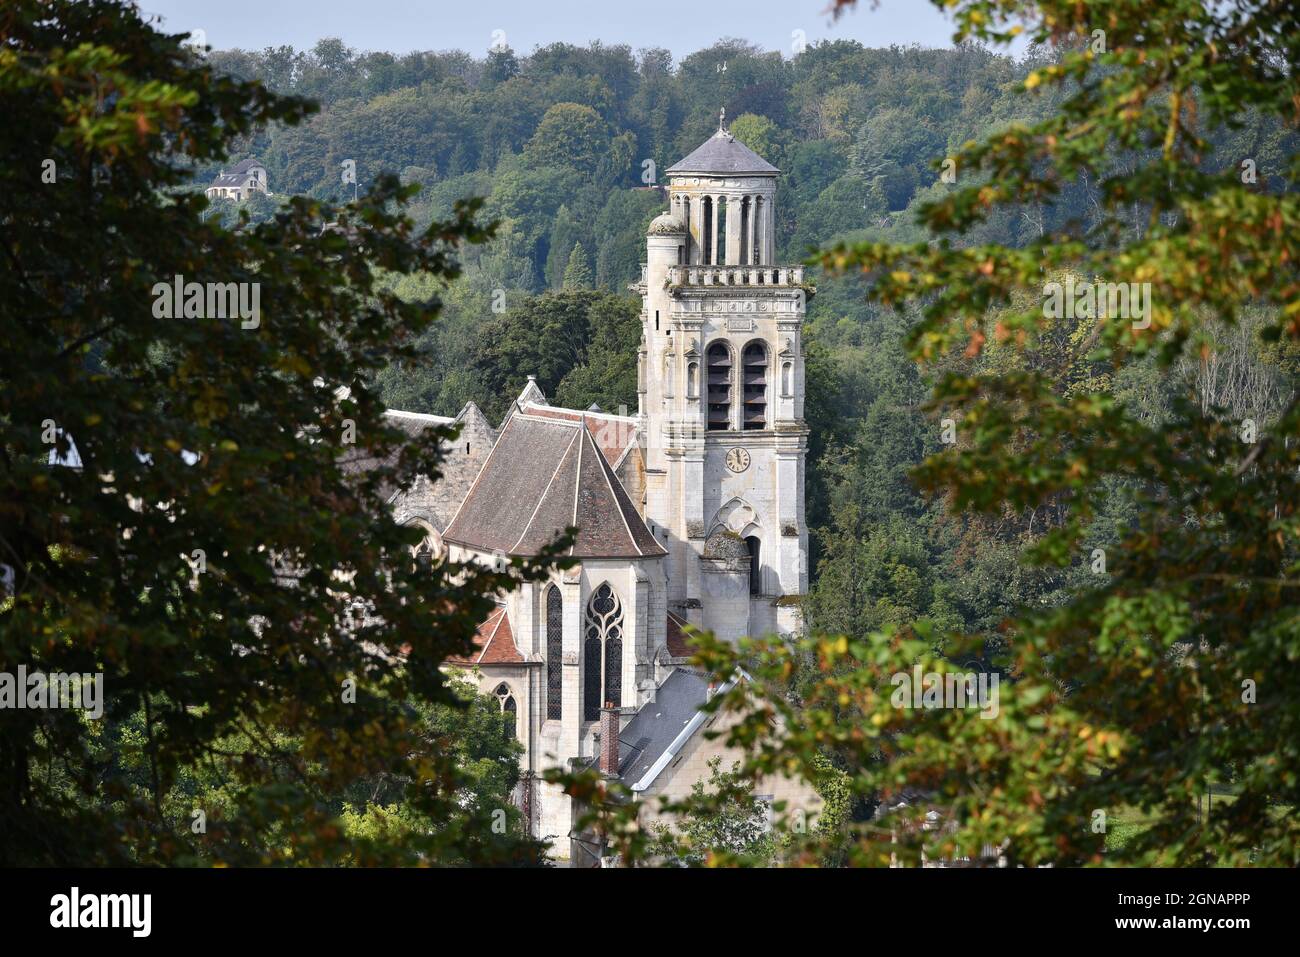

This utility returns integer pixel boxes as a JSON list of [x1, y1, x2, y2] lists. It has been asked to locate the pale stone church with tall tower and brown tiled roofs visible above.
[[387, 124, 820, 866]]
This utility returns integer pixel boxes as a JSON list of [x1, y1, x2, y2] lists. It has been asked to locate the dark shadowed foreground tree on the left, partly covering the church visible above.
[[0, 0, 566, 866]]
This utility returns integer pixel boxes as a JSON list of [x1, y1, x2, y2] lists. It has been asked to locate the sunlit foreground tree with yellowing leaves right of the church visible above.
[[561, 0, 1300, 866]]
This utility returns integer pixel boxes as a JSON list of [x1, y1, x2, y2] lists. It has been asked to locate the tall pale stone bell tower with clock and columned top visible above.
[[633, 113, 810, 638]]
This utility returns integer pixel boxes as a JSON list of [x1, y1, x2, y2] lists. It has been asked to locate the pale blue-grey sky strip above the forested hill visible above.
[[137, 0, 972, 59]]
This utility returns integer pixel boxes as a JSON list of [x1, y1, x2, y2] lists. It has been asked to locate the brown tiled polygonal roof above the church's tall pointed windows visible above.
[[442, 408, 667, 558]]
